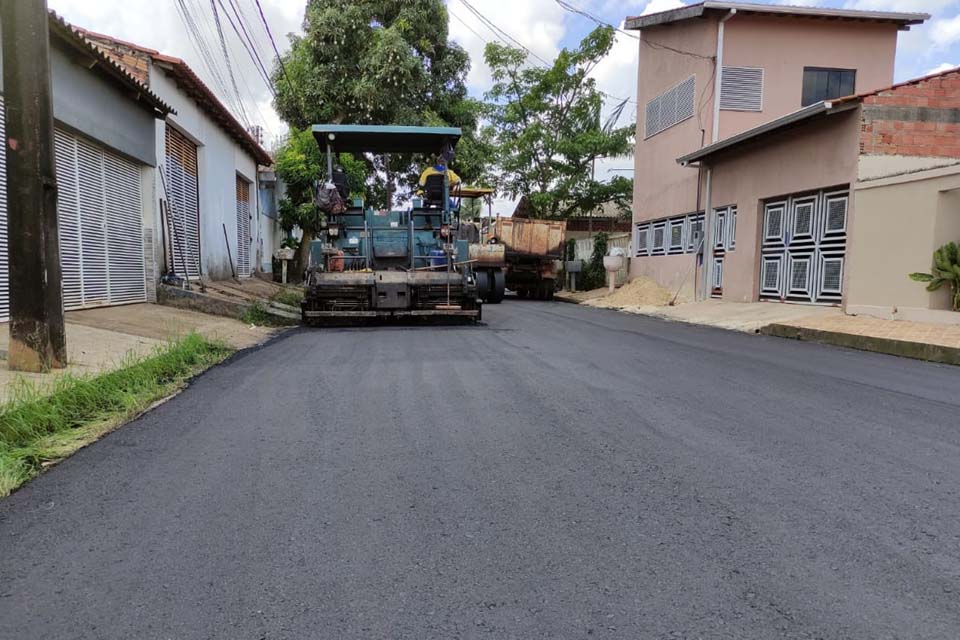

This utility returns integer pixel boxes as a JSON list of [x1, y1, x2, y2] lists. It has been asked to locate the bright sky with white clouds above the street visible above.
[[48, 0, 960, 213]]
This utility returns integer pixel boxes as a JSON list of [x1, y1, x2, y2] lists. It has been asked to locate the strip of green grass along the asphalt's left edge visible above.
[[0, 333, 232, 497]]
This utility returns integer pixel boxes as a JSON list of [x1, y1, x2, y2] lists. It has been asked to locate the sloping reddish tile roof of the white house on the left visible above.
[[78, 29, 273, 165]]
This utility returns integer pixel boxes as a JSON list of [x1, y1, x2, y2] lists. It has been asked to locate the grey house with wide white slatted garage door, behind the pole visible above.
[[0, 13, 174, 322]]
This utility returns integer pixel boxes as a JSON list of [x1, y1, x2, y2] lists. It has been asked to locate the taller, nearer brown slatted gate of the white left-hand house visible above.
[[165, 124, 200, 278]]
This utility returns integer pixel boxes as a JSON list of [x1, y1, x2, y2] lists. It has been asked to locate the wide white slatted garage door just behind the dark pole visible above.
[[0, 98, 146, 321]]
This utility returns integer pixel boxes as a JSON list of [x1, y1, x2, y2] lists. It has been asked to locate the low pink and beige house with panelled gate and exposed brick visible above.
[[680, 69, 960, 323]]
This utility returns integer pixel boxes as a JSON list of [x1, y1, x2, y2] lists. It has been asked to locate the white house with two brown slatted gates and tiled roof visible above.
[[84, 31, 280, 280]]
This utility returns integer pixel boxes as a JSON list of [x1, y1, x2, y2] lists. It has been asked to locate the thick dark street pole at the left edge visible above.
[[0, 0, 67, 371]]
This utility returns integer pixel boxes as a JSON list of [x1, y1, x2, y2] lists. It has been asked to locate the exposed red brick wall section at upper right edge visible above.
[[860, 71, 960, 158]]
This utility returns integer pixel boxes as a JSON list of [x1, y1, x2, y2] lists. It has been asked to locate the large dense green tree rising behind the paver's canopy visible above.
[[273, 0, 486, 206]]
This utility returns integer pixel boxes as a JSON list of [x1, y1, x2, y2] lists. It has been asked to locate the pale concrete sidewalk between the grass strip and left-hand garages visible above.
[[0, 304, 277, 402]]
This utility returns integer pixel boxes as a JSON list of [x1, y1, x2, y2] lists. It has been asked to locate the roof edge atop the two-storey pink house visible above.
[[626, 1, 930, 30]]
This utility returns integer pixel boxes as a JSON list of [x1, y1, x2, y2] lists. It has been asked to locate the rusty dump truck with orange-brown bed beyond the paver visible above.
[[481, 218, 567, 300]]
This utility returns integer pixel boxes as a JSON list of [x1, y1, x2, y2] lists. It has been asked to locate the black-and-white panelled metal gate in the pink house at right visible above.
[[760, 187, 850, 304]]
